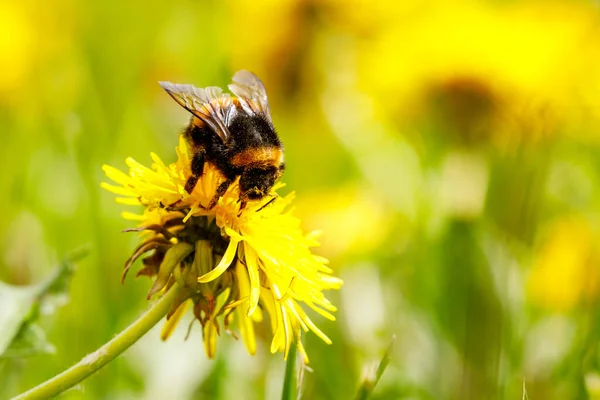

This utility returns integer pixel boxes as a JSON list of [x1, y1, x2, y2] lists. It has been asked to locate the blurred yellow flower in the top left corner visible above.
[[0, 0, 82, 104]]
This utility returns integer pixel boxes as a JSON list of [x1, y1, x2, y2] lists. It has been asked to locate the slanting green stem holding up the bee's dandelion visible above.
[[13, 283, 181, 400]]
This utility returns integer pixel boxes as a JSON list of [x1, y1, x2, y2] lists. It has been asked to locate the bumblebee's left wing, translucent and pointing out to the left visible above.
[[159, 82, 236, 143]]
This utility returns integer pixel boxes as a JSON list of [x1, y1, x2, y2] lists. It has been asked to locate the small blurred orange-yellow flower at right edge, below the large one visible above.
[[527, 217, 600, 312]]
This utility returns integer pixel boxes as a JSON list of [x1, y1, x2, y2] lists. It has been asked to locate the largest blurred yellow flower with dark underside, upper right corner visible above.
[[357, 0, 600, 146]]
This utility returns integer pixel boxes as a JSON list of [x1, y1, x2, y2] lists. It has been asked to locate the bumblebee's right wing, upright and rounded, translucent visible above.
[[229, 70, 272, 122]]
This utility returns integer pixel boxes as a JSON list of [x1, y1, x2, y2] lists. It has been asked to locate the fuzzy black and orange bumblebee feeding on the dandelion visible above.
[[159, 71, 285, 210]]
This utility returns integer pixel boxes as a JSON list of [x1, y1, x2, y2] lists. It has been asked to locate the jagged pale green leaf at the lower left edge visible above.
[[0, 250, 88, 359]]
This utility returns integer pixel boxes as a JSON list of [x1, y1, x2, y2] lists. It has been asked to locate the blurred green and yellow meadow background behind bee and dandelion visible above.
[[0, 0, 600, 399]]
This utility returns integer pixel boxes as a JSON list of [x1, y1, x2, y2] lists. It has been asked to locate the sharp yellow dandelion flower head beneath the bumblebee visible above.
[[102, 137, 342, 362]]
